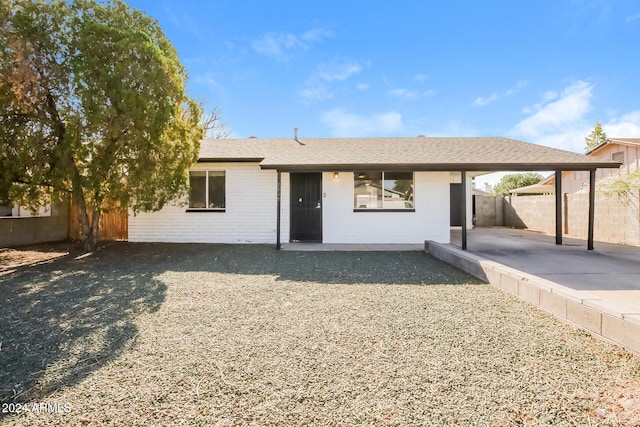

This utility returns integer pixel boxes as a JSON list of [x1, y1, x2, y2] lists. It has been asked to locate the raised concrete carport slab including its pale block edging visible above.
[[425, 227, 640, 354]]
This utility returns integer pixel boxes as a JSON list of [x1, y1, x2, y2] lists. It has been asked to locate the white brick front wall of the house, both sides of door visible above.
[[129, 169, 449, 244]]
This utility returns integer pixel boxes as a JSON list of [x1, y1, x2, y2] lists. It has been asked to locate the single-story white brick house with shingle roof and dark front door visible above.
[[128, 132, 618, 248]]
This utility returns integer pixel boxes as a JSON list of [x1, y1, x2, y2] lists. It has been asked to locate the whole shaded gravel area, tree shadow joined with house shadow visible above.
[[0, 242, 481, 410]]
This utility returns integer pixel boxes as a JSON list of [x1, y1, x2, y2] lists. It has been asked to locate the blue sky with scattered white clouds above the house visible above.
[[128, 0, 640, 182]]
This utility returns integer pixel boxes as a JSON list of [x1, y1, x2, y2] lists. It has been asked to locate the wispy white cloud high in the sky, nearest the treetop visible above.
[[251, 28, 333, 61]]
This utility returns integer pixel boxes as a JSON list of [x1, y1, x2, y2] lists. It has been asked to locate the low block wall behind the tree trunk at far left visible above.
[[0, 200, 69, 247]]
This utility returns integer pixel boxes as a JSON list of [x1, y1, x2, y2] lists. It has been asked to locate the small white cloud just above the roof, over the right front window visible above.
[[321, 108, 404, 137]]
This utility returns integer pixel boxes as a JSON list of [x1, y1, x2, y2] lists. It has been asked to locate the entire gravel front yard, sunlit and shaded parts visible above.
[[0, 243, 640, 426]]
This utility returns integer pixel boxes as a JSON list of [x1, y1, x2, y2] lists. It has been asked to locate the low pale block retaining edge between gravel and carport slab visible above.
[[424, 241, 640, 355]]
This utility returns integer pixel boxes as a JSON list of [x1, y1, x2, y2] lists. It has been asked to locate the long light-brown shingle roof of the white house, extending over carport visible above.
[[200, 137, 619, 171]]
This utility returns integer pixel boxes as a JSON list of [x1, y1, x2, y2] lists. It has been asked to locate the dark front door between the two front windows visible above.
[[290, 173, 322, 243]]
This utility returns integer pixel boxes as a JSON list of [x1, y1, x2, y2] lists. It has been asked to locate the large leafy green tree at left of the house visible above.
[[0, 0, 203, 250]]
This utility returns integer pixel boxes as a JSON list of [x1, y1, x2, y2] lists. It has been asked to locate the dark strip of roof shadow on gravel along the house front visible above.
[[105, 243, 483, 285]]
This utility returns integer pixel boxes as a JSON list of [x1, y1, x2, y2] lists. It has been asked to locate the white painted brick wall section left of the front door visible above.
[[129, 163, 278, 244]]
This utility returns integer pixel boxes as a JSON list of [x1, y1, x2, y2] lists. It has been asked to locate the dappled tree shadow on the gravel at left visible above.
[[0, 244, 166, 408]]
